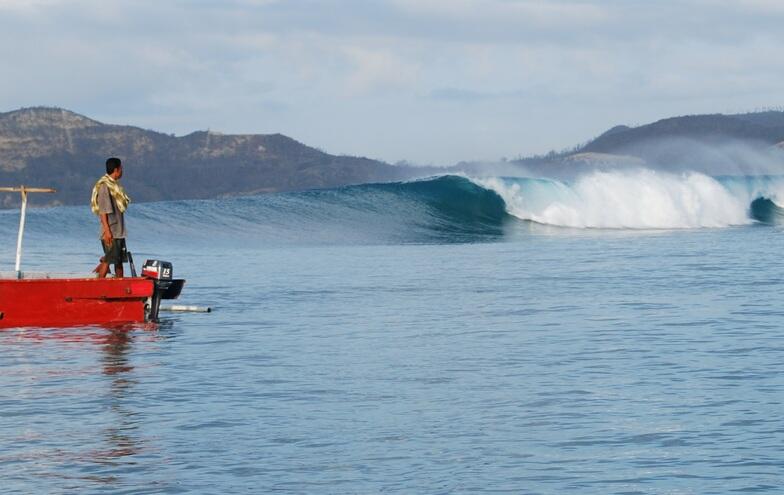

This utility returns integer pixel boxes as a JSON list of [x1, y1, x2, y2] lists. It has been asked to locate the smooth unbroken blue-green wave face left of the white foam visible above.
[[0, 176, 515, 250]]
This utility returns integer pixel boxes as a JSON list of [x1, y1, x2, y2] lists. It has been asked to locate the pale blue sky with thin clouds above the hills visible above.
[[0, 0, 784, 165]]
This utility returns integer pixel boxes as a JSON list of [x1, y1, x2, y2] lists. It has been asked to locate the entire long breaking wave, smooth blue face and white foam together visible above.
[[0, 170, 784, 249]]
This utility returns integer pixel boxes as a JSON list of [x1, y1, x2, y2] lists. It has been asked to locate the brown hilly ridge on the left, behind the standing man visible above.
[[0, 107, 416, 207]]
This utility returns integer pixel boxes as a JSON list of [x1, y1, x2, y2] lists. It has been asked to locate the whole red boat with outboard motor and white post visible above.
[[0, 186, 185, 328]]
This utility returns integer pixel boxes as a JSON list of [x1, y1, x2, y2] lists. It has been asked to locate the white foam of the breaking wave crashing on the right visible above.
[[476, 169, 751, 229]]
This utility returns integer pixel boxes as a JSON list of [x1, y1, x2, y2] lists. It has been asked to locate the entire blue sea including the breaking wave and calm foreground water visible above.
[[0, 170, 784, 494]]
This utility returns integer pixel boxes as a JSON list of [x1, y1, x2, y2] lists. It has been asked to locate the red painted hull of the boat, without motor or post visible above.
[[0, 277, 155, 328]]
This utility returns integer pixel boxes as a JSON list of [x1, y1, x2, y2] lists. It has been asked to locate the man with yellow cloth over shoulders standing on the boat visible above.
[[90, 158, 131, 278]]
